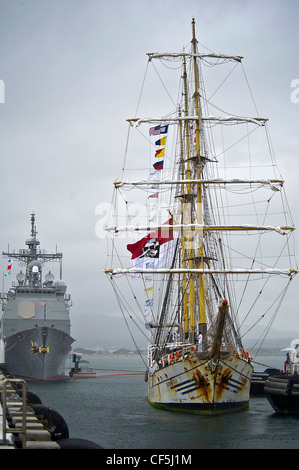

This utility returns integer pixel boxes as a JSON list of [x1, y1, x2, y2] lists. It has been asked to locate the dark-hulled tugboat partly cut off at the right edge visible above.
[[264, 339, 299, 413]]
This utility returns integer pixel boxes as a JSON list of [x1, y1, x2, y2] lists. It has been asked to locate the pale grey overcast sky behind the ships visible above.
[[0, 0, 299, 346]]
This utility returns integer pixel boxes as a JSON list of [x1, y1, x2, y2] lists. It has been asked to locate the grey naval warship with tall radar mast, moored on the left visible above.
[[1, 213, 74, 380]]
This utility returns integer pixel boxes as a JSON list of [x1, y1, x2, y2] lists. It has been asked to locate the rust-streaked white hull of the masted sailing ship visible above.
[[148, 355, 253, 414]]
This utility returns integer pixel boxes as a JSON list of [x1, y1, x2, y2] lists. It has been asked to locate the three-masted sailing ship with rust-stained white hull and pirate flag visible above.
[[105, 19, 297, 414]]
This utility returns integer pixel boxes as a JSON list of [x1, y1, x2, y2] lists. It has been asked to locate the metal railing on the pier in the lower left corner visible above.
[[1, 378, 27, 449]]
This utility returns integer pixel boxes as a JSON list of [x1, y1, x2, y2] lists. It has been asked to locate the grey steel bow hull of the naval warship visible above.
[[5, 327, 74, 380]]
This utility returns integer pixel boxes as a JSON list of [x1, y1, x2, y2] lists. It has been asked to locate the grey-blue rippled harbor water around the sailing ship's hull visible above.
[[27, 356, 299, 450]]
